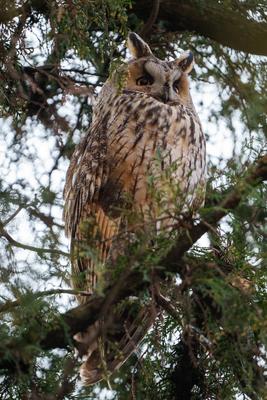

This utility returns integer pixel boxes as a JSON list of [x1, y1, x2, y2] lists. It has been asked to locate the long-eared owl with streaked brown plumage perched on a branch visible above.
[[64, 32, 206, 384]]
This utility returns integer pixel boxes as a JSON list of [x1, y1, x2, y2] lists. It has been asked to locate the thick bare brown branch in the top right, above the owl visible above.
[[133, 0, 267, 55]]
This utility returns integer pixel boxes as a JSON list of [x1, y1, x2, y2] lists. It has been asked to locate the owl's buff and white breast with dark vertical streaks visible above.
[[98, 93, 205, 214]]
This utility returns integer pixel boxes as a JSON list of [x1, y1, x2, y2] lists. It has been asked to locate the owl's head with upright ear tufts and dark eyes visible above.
[[125, 32, 194, 106]]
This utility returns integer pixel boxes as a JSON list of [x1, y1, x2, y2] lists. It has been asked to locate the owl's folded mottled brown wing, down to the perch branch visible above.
[[64, 124, 119, 296]]
